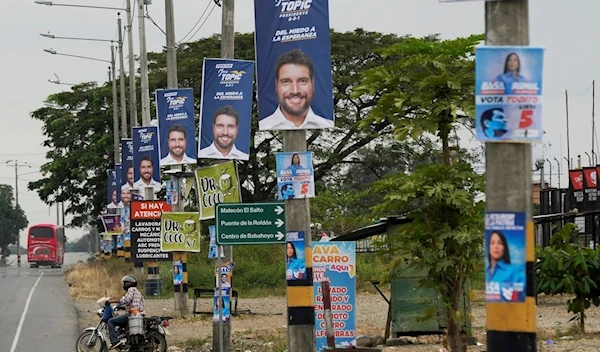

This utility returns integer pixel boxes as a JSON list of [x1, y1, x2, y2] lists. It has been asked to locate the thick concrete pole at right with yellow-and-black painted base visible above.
[[485, 0, 543, 352]]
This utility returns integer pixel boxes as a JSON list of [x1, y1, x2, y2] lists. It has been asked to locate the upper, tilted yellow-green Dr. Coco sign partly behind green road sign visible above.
[[196, 160, 242, 220]]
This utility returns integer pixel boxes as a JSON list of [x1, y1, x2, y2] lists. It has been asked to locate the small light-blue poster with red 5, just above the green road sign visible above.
[[275, 152, 315, 200]]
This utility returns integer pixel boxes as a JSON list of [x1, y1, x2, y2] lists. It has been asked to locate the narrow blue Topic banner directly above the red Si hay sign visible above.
[[133, 126, 161, 194]]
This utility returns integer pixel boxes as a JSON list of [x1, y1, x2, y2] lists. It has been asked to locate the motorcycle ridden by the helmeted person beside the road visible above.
[[76, 299, 173, 352]]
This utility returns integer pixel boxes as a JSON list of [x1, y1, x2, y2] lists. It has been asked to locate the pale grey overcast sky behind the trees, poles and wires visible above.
[[0, 0, 600, 240]]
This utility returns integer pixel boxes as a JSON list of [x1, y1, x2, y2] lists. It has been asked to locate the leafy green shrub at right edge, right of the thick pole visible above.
[[536, 223, 600, 332]]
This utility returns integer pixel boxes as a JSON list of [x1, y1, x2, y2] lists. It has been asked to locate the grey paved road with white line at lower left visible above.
[[0, 267, 80, 352]]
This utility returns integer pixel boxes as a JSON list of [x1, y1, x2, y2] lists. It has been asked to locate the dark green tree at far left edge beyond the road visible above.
[[0, 185, 29, 261]]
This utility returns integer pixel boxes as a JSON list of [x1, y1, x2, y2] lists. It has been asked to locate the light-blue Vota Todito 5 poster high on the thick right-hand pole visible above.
[[475, 46, 544, 142]]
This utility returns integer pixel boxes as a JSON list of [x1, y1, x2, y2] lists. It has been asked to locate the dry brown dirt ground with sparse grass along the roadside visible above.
[[76, 293, 600, 352]]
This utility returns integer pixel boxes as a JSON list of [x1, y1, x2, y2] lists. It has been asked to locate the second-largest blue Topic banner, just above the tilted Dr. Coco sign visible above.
[[198, 58, 254, 160]]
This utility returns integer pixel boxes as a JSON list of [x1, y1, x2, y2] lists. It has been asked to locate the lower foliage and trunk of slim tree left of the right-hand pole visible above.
[[374, 163, 484, 352]]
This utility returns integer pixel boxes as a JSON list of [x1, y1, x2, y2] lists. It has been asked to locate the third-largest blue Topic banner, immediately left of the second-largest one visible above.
[[155, 88, 196, 166]]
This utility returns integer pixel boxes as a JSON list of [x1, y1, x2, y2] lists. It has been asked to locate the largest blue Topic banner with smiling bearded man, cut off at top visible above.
[[254, 0, 334, 130]]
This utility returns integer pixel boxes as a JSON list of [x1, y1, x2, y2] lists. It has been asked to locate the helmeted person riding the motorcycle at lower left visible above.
[[108, 275, 145, 350]]
